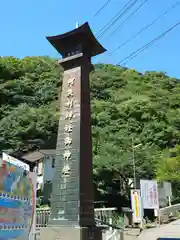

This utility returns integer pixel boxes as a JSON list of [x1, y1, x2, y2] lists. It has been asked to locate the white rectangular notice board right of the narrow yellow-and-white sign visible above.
[[140, 180, 159, 210]]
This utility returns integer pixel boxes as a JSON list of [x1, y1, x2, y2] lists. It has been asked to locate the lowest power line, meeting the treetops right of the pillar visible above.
[[117, 21, 180, 65]]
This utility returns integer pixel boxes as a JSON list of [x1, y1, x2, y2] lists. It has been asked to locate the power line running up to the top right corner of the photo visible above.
[[108, 1, 180, 56]]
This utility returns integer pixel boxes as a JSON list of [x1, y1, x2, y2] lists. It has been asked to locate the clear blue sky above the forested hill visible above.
[[0, 0, 180, 78]]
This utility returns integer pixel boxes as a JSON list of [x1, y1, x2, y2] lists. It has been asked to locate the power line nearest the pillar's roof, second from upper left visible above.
[[97, 0, 138, 38]]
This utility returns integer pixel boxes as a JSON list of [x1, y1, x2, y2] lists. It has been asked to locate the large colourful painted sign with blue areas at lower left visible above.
[[0, 154, 36, 240]]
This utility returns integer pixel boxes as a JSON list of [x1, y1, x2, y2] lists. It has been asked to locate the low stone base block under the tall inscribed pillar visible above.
[[40, 226, 102, 240]]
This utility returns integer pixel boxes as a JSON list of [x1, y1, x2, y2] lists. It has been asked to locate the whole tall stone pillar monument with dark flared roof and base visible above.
[[41, 23, 105, 240]]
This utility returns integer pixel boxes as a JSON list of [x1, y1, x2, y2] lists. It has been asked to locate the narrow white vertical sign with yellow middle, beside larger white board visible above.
[[131, 190, 142, 223]]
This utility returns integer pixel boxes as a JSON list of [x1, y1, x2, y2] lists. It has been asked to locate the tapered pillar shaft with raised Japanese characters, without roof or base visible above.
[[50, 57, 94, 226]]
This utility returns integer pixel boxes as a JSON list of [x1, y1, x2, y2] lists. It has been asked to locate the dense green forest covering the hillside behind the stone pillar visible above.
[[0, 57, 180, 206]]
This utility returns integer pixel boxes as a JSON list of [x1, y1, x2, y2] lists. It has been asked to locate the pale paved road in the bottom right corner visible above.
[[137, 220, 180, 240]]
